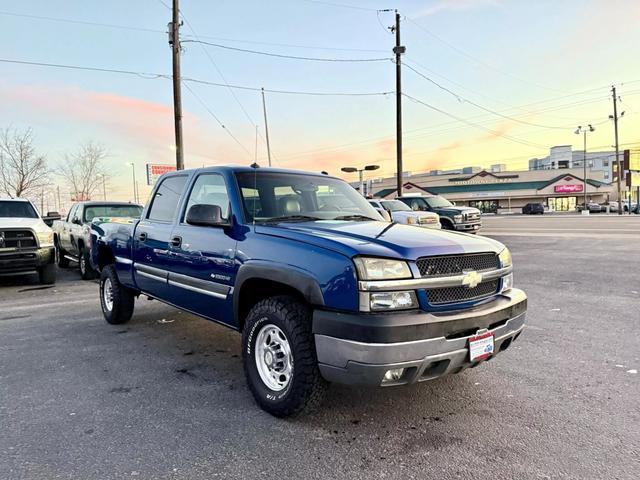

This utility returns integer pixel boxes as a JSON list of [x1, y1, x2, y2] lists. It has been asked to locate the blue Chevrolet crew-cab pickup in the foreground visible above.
[[91, 165, 527, 417]]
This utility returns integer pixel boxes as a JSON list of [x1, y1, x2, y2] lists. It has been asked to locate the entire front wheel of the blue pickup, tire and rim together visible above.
[[242, 296, 328, 417]]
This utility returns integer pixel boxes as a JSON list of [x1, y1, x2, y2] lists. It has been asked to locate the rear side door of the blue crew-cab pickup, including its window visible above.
[[133, 174, 188, 301]]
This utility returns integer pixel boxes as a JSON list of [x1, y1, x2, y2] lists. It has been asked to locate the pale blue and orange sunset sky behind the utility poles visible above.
[[0, 0, 640, 204]]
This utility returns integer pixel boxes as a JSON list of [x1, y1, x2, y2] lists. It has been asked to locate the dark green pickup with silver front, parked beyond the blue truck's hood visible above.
[[398, 195, 482, 233]]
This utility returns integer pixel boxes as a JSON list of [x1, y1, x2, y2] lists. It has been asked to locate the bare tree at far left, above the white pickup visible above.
[[0, 127, 49, 198]]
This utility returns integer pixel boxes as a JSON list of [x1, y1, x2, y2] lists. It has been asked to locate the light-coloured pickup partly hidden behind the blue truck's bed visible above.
[[53, 202, 142, 280]]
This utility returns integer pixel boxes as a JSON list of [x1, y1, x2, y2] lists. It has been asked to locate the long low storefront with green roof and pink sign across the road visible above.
[[373, 169, 613, 213]]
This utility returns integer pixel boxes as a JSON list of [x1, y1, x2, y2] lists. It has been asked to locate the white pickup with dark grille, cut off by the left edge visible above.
[[0, 198, 56, 285]]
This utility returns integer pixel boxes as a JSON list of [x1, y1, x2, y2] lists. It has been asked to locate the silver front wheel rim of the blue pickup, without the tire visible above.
[[254, 324, 293, 392]]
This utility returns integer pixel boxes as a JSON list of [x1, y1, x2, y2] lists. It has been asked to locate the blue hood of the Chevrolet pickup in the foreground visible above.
[[255, 221, 504, 260]]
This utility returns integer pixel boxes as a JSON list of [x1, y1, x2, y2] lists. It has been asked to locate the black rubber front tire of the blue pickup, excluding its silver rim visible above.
[[242, 296, 328, 417]]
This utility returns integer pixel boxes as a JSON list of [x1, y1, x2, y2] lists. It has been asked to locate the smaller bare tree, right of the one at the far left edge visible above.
[[58, 141, 110, 200]]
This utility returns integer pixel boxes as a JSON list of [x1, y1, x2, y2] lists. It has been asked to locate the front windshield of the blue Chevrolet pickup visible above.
[[236, 170, 382, 223]]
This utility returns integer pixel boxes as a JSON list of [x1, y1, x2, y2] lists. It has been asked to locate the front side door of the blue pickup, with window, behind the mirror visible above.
[[169, 173, 237, 325]]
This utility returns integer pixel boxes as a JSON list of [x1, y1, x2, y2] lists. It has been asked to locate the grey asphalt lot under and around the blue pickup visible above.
[[0, 215, 640, 479]]
